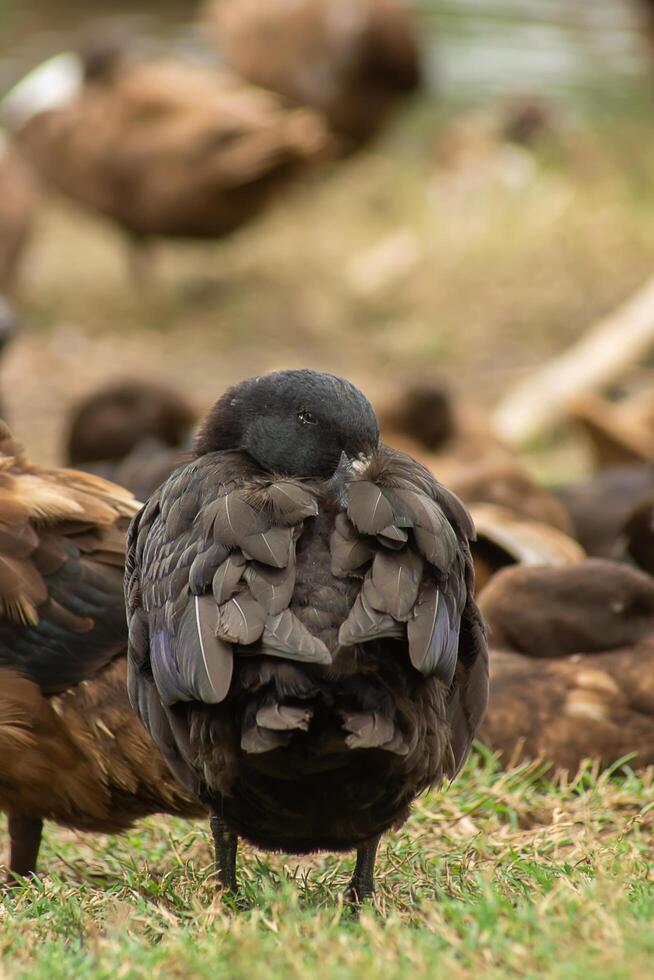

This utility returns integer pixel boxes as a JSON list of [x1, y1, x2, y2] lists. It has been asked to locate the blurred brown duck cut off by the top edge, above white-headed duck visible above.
[[203, 0, 421, 147]]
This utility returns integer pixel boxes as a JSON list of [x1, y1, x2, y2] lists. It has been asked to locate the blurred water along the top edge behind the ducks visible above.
[[0, 0, 654, 111]]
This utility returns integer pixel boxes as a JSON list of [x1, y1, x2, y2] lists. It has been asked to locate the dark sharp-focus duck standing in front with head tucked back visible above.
[[126, 371, 487, 899]]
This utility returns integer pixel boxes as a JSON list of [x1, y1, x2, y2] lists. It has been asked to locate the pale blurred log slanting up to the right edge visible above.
[[492, 277, 654, 445]]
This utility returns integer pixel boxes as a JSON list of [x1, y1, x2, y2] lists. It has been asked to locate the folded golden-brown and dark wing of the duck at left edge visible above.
[[0, 423, 138, 694]]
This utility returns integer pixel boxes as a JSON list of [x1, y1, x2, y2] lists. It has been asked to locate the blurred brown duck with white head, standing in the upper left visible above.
[[4, 51, 328, 256]]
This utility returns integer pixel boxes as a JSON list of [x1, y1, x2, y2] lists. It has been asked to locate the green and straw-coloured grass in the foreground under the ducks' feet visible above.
[[0, 755, 654, 980]]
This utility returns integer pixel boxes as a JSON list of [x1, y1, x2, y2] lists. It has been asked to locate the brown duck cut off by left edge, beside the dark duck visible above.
[[0, 424, 203, 875]]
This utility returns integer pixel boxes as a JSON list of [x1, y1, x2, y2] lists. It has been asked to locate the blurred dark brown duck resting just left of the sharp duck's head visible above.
[[64, 378, 197, 500]]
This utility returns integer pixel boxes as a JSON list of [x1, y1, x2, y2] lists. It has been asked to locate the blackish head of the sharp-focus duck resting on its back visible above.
[[196, 370, 379, 478]]
